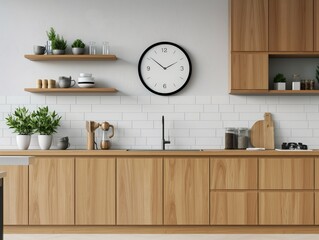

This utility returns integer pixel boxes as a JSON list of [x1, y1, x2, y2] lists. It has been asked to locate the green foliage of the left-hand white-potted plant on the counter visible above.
[[6, 107, 35, 135]]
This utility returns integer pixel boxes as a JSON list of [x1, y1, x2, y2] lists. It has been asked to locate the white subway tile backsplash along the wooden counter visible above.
[[0, 95, 319, 149]]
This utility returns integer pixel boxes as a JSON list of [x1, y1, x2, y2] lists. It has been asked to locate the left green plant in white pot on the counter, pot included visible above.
[[6, 107, 34, 150]]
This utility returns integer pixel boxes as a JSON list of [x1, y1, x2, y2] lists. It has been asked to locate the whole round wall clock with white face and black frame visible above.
[[138, 42, 192, 95]]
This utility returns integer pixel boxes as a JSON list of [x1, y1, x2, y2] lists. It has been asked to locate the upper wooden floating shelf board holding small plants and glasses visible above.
[[24, 55, 117, 61]]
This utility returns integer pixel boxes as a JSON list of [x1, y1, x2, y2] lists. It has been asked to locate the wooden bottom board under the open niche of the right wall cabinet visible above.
[[230, 90, 319, 95]]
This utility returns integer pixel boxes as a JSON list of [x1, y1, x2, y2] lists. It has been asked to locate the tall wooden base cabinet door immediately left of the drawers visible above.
[[164, 157, 209, 225]]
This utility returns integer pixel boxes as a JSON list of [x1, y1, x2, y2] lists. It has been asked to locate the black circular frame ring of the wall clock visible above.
[[138, 42, 192, 96]]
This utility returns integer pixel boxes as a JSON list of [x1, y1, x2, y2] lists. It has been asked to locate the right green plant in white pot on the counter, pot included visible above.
[[32, 106, 61, 150]]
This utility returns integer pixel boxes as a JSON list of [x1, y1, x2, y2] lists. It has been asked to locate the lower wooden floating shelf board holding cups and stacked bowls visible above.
[[24, 88, 117, 93]]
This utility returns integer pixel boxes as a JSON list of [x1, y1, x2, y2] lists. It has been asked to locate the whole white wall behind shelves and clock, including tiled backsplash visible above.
[[0, 0, 319, 148]]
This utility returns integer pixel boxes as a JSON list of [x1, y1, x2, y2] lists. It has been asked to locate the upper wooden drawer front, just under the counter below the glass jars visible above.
[[210, 158, 257, 189]]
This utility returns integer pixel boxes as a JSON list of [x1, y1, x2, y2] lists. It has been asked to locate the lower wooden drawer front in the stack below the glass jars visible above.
[[210, 191, 257, 225]]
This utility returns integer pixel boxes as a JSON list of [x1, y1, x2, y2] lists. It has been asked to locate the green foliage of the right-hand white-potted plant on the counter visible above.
[[32, 106, 61, 135]]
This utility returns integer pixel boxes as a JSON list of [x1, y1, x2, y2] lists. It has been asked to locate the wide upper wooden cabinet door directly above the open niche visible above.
[[269, 0, 313, 51]]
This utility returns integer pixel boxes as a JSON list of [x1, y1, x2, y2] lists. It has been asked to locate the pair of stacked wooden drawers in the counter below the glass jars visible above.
[[210, 157, 257, 225]]
